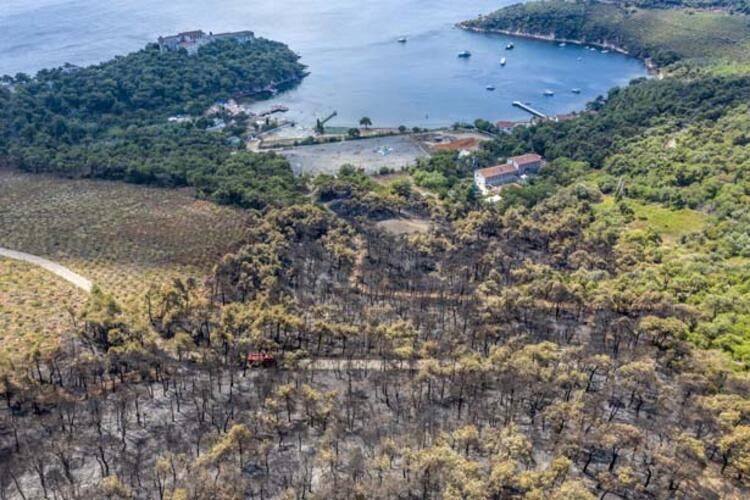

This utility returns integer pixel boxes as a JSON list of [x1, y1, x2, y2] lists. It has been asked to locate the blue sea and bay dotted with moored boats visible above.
[[0, 0, 646, 127]]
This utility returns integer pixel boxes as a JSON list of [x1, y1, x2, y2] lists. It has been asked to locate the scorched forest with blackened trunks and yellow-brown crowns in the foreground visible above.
[[0, 198, 750, 499]]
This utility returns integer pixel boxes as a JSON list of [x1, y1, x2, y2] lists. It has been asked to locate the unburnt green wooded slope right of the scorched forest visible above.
[[458, 2, 750, 365]]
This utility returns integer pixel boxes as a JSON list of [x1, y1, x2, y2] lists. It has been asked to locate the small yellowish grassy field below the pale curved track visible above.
[[0, 258, 86, 359]]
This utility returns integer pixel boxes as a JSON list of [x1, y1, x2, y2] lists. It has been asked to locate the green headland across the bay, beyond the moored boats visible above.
[[462, 0, 750, 67]]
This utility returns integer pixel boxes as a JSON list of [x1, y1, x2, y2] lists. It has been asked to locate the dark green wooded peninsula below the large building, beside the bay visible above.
[[0, 39, 304, 208]]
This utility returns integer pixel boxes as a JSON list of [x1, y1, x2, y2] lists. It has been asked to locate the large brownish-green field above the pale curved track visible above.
[[0, 170, 250, 307]]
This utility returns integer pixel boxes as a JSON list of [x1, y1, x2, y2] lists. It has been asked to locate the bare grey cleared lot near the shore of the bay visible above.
[[280, 136, 427, 174]]
